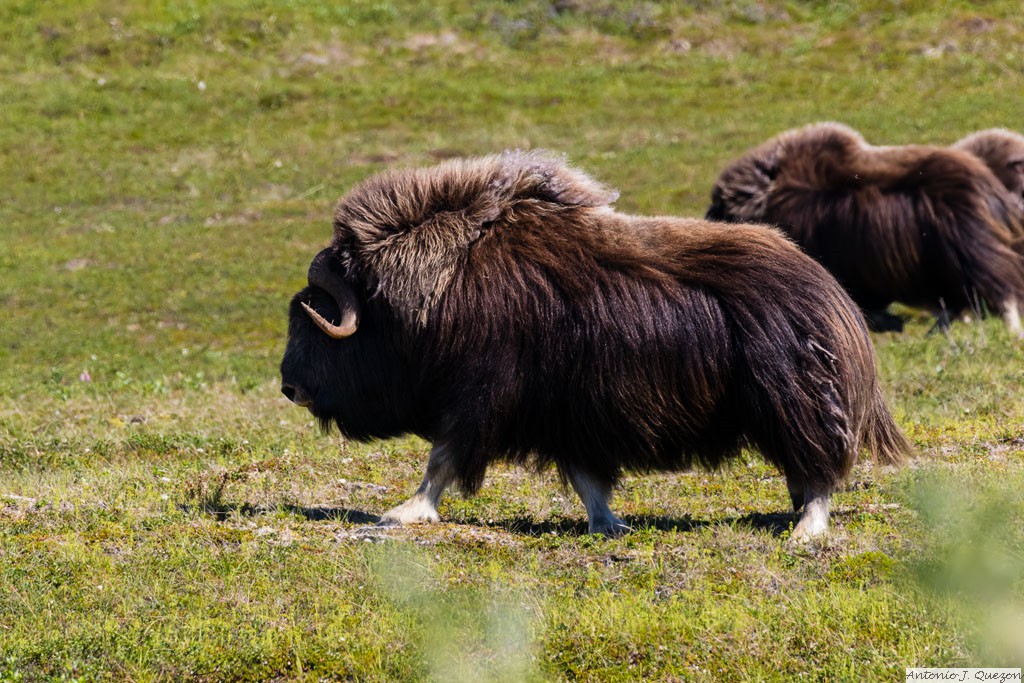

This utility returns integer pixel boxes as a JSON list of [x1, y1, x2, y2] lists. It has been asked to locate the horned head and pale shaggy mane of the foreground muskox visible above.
[[281, 152, 616, 440]]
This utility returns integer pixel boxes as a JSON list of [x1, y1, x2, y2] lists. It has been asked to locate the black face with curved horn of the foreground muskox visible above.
[[281, 249, 412, 440]]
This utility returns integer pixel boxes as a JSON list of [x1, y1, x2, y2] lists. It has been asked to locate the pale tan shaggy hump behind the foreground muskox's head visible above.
[[334, 151, 618, 325]]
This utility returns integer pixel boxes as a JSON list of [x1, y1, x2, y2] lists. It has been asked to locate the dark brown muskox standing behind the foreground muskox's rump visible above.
[[707, 123, 1024, 334]]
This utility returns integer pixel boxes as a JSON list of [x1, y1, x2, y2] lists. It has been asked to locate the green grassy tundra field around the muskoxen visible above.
[[0, 0, 1024, 683]]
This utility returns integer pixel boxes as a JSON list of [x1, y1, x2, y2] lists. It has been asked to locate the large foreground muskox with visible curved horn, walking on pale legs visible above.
[[281, 153, 907, 540]]
